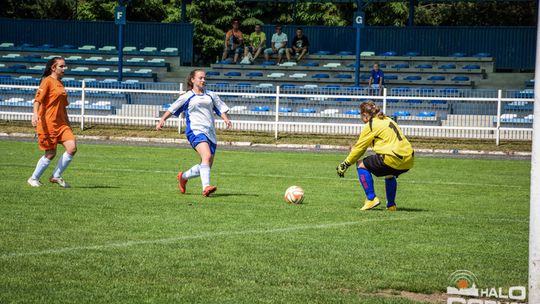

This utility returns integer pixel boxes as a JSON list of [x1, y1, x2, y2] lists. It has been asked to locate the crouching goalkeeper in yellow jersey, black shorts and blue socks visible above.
[[336, 101, 414, 211]]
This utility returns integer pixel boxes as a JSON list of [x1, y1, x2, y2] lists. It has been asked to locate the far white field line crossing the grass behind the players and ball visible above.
[[0, 163, 529, 189]]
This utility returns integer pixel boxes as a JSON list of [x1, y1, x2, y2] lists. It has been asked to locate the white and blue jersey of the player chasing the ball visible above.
[[168, 90, 229, 143]]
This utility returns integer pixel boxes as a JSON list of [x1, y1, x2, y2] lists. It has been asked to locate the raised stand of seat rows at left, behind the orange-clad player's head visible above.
[[0, 42, 184, 82]]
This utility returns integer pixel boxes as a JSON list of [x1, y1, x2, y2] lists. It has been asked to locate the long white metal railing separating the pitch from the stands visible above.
[[0, 81, 534, 145]]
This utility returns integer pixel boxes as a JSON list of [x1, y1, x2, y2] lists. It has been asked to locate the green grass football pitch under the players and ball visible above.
[[0, 141, 530, 303]]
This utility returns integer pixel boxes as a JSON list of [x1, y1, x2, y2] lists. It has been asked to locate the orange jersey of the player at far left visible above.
[[34, 76, 69, 136]]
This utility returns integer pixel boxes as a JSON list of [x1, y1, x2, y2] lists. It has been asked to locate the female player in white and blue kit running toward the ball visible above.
[[156, 69, 232, 197]]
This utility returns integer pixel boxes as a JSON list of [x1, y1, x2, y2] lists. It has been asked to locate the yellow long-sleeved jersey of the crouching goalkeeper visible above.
[[345, 116, 414, 170]]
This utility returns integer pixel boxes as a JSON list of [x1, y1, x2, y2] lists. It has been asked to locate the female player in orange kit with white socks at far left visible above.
[[28, 57, 77, 188]]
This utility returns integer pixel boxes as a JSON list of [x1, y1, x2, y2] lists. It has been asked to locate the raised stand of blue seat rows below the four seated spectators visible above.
[[208, 51, 495, 88]]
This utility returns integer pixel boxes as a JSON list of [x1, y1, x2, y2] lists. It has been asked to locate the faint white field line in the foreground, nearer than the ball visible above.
[[0, 216, 417, 259]]
